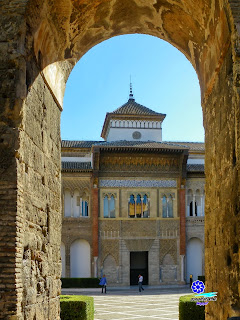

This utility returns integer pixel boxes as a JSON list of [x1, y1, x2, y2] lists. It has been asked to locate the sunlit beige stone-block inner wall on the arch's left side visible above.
[[18, 75, 62, 319]]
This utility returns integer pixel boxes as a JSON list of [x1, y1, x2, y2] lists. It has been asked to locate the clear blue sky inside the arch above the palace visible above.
[[61, 35, 204, 142]]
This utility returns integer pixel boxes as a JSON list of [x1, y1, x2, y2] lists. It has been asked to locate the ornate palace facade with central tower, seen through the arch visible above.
[[61, 90, 205, 286]]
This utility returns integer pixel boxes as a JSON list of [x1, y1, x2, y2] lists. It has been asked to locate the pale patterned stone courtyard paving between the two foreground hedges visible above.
[[62, 287, 191, 320]]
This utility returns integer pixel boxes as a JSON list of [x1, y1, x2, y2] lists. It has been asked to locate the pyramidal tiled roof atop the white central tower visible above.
[[112, 99, 165, 115]]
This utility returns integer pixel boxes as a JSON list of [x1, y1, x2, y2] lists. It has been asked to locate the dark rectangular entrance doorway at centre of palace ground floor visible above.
[[130, 251, 148, 286]]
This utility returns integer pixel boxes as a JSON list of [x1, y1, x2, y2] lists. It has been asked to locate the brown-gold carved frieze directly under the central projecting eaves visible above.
[[100, 156, 179, 171]]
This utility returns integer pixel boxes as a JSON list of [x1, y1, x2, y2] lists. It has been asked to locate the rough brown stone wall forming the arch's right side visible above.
[[204, 43, 240, 319]]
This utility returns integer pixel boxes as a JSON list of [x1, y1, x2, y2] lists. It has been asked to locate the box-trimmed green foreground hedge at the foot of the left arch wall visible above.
[[60, 296, 94, 320]]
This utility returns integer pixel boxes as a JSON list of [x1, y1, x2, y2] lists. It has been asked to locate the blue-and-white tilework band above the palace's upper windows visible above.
[[99, 179, 177, 188]]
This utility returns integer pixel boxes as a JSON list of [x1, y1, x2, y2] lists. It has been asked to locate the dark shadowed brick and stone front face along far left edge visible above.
[[0, 1, 28, 319]]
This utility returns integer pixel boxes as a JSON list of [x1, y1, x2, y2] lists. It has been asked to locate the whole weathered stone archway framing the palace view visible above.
[[0, 0, 240, 320]]
